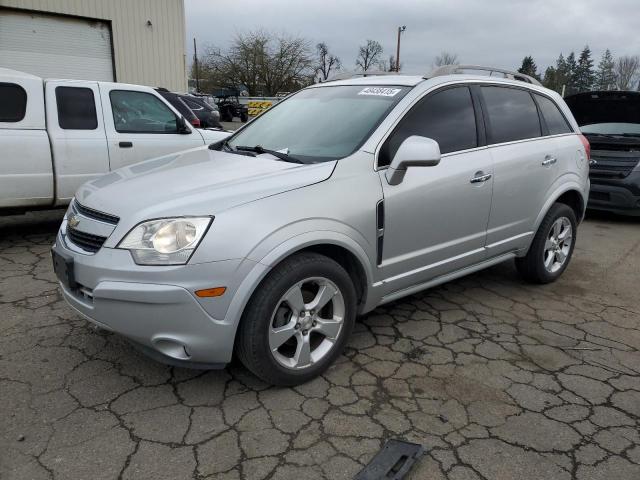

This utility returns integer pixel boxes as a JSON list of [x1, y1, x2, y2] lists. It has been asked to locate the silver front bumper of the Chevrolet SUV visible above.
[[53, 234, 256, 368]]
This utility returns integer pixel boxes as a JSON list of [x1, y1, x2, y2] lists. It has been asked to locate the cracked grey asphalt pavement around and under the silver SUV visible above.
[[0, 212, 640, 480]]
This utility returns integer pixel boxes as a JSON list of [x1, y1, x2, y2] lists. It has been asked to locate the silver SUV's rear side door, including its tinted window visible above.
[[480, 85, 558, 255]]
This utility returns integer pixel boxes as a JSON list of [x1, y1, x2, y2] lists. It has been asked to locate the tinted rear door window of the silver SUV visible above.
[[482, 87, 542, 143]]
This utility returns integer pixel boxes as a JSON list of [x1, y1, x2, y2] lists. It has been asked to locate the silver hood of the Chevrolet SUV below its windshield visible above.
[[76, 147, 336, 221]]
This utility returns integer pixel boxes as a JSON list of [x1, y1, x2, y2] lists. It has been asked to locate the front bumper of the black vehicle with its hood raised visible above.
[[588, 171, 640, 215]]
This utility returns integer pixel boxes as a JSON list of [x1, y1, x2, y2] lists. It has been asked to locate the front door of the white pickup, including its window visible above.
[[100, 84, 204, 170]]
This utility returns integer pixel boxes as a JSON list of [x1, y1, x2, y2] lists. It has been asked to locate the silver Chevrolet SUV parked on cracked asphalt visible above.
[[52, 66, 589, 385]]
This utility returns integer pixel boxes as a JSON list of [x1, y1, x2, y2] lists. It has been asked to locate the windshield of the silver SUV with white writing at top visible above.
[[228, 85, 408, 162]]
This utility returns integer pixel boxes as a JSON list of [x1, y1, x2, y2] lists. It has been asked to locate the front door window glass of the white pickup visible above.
[[109, 90, 178, 133]]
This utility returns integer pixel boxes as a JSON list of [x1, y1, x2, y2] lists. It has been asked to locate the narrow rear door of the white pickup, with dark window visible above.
[[45, 80, 109, 204]]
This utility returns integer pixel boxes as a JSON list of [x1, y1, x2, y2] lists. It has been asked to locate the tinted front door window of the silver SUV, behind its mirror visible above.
[[378, 83, 478, 166]]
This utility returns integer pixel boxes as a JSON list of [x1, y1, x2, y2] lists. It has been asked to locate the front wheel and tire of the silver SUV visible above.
[[236, 253, 357, 386]]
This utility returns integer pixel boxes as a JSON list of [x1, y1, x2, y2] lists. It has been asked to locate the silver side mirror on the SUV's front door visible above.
[[385, 135, 440, 185]]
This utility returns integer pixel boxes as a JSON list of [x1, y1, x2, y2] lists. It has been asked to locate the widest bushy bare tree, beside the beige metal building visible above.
[[201, 30, 313, 95]]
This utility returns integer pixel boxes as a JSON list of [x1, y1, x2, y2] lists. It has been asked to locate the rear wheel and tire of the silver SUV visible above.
[[516, 203, 578, 284]]
